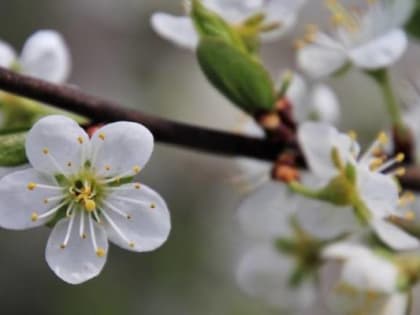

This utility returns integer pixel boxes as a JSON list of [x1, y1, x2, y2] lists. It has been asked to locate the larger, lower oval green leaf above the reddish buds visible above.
[[197, 37, 276, 114]]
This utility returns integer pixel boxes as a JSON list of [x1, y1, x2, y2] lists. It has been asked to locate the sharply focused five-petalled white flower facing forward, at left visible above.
[[0, 116, 171, 284]]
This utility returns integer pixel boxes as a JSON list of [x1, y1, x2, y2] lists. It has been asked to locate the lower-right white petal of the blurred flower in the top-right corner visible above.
[[350, 29, 408, 70]]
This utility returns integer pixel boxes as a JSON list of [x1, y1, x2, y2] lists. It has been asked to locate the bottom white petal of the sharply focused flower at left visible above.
[[45, 214, 108, 284]]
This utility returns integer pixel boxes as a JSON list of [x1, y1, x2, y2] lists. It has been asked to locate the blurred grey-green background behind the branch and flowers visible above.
[[0, 0, 419, 315]]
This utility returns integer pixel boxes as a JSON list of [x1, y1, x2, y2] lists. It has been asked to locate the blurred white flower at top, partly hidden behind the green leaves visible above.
[[151, 0, 305, 49]]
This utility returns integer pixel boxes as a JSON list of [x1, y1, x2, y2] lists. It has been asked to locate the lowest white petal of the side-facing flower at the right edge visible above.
[[371, 219, 420, 250]]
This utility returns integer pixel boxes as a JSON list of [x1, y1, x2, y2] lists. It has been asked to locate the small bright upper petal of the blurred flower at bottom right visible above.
[[322, 241, 371, 260]]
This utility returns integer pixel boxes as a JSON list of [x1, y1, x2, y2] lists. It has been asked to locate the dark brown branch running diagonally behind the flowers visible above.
[[0, 67, 420, 191]]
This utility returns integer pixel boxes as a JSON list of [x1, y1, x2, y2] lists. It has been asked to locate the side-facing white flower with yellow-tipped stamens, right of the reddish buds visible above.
[[298, 122, 419, 250]]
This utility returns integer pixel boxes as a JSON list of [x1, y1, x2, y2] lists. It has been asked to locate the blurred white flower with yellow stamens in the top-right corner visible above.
[[297, 0, 414, 77]]
